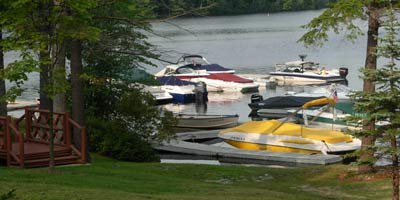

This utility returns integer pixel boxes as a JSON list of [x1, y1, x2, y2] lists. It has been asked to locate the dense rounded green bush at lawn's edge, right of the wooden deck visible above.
[[87, 85, 177, 162]]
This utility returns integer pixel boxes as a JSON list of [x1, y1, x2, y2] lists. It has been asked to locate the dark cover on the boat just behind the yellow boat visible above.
[[249, 96, 325, 110]]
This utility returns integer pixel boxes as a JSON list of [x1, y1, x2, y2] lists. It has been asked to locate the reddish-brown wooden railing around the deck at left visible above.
[[0, 108, 87, 167]]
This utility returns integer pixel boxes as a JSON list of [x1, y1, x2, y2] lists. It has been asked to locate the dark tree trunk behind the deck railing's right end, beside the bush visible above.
[[71, 39, 90, 162]]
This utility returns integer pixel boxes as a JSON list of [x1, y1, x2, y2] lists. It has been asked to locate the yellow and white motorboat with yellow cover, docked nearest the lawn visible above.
[[218, 120, 361, 154]]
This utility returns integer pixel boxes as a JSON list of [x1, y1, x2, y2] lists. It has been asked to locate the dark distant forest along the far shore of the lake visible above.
[[155, 0, 337, 17]]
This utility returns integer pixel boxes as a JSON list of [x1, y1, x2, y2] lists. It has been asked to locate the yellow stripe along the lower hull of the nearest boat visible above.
[[225, 140, 321, 154]]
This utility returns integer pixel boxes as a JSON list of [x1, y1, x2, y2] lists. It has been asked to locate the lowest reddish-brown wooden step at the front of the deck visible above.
[[11, 155, 79, 168]]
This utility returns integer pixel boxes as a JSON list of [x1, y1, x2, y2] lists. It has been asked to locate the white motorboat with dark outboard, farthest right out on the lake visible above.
[[269, 55, 348, 86]]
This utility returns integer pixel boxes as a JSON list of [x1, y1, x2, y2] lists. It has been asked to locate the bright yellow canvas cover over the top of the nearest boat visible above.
[[220, 120, 353, 144]]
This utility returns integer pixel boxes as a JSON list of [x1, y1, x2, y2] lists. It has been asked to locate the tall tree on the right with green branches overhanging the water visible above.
[[299, 0, 390, 172]]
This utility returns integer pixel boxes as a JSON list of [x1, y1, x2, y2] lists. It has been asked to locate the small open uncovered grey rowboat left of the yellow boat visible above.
[[174, 113, 239, 129]]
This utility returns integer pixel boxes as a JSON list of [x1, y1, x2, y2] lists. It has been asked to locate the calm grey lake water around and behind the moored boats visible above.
[[147, 10, 367, 122]]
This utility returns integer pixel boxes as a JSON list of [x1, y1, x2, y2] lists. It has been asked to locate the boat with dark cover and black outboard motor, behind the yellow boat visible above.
[[248, 94, 322, 118]]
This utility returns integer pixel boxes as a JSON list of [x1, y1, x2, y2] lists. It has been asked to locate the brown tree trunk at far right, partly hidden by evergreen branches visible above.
[[359, 3, 379, 173]]
